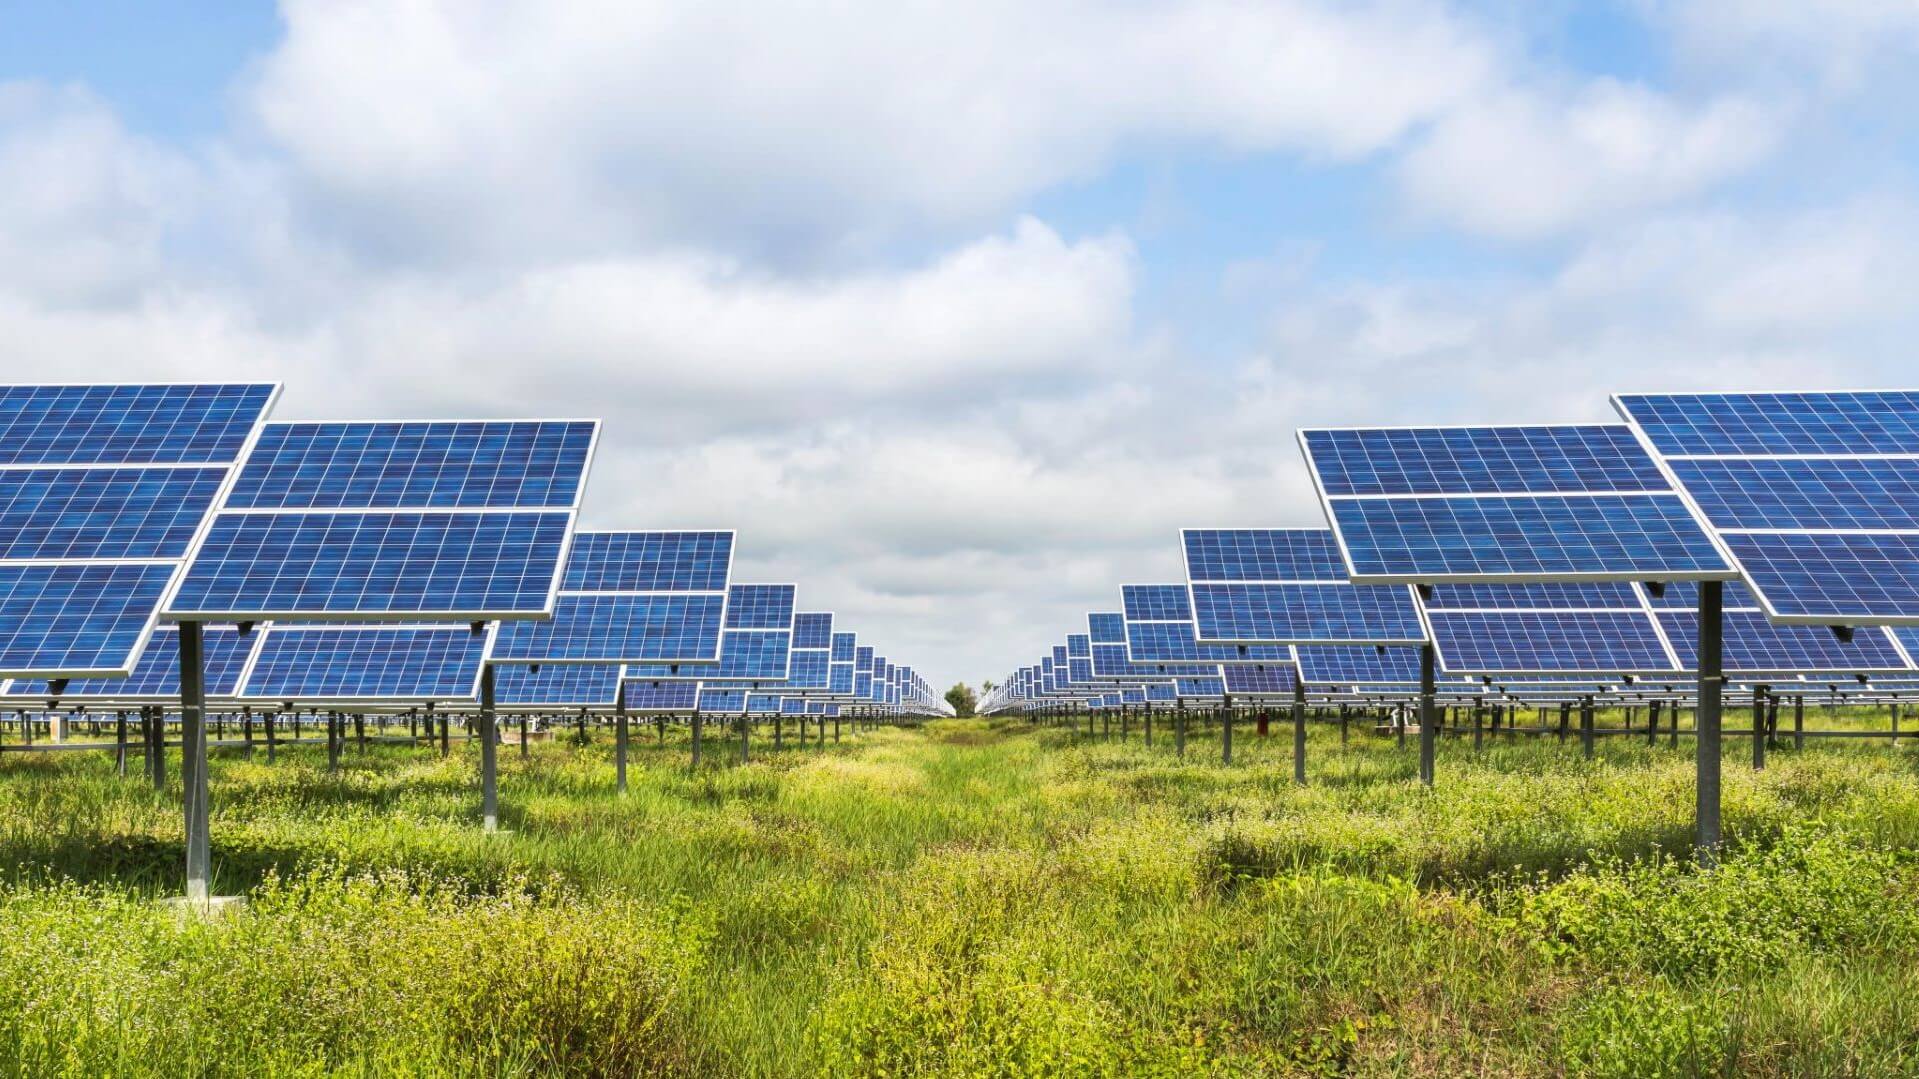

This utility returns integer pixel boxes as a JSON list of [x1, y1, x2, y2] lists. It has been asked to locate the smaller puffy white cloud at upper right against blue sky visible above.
[[1399, 79, 1781, 238]]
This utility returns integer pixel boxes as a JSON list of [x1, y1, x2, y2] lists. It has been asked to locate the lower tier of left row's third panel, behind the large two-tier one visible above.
[[493, 593, 723, 664]]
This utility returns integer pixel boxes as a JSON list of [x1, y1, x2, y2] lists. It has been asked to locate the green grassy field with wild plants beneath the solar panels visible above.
[[0, 720, 1919, 1075]]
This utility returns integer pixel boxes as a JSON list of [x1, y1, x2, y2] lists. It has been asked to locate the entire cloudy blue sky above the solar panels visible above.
[[0, 0, 1919, 685]]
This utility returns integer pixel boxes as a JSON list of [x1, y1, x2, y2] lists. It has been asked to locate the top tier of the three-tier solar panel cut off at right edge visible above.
[[1614, 392, 1919, 455]]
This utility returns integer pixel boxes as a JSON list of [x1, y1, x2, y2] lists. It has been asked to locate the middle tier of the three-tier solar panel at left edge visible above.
[[0, 468, 226, 559]]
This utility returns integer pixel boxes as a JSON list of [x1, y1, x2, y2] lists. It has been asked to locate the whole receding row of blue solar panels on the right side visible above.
[[983, 392, 1919, 708]]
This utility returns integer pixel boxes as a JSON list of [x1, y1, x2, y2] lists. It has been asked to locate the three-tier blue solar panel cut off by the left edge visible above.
[[0, 384, 278, 678]]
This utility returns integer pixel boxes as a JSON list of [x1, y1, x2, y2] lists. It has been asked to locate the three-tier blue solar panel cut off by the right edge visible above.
[[1612, 392, 1919, 624]]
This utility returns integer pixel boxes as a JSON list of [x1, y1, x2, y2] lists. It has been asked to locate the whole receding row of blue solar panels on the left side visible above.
[[0, 384, 951, 712]]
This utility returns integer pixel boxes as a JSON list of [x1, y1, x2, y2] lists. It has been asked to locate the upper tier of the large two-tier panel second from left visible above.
[[226, 420, 599, 509]]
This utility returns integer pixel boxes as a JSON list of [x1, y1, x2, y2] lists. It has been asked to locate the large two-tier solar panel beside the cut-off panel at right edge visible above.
[[1299, 424, 1733, 584]]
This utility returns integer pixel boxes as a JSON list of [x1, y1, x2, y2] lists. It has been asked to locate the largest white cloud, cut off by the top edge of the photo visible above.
[[248, 0, 1491, 259]]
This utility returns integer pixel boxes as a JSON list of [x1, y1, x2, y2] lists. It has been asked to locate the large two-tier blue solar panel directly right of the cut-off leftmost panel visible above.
[[167, 420, 599, 622]]
